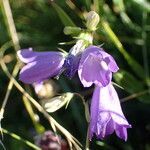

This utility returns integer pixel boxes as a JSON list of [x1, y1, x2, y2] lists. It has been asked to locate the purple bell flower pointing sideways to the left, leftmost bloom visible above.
[[17, 48, 65, 84]]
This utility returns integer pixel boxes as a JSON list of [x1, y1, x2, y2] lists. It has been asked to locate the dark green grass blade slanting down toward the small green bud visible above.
[[52, 3, 76, 27]]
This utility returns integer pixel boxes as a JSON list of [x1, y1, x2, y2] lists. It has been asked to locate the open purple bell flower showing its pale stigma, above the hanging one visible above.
[[78, 46, 119, 87]]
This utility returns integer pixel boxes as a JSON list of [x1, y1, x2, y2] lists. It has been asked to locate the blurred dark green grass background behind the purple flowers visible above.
[[0, 0, 150, 150]]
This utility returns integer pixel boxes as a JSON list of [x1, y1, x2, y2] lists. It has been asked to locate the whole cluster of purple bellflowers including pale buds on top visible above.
[[18, 12, 131, 141]]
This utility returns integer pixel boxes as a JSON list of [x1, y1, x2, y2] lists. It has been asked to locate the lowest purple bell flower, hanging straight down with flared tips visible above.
[[89, 83, 131, 141]]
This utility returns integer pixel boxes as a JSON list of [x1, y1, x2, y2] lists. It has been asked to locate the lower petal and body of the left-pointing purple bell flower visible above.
[[20, 52, 64, 84]]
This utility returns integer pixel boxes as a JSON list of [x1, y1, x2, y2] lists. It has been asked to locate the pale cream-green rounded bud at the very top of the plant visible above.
[[85, 11, 100, 31]]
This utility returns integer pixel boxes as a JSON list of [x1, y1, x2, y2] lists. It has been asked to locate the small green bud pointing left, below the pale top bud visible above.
[[64, 26, 81, 35]]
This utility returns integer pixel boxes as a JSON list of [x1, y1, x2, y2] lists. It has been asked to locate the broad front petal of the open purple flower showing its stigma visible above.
[[78, 54, 111, 87]]
